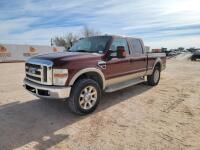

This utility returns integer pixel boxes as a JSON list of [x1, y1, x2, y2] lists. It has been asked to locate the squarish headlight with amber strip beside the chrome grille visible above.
[[53, 69, 68, 85]]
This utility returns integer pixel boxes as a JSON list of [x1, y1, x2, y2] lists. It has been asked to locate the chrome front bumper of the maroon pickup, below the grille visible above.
[[23, 79, 71, 99]]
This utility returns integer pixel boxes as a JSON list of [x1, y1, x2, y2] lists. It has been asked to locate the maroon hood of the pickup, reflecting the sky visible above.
[[32, 52, 102, 66]]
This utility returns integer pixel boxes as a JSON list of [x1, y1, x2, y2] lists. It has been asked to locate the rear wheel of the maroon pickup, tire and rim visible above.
[[147, 66, 160, 86]]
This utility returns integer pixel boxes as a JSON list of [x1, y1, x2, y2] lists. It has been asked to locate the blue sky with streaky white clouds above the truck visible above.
[[0, 0, 200, 48]]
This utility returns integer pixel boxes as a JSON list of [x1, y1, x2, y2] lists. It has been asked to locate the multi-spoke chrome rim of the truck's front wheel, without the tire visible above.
[[79, 86, 97, 110]]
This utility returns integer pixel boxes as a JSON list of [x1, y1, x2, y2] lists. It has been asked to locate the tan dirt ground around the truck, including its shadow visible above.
[[0, 56, 200, 150]]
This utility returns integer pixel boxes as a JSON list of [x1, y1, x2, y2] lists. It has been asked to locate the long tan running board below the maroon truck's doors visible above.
[[105, 78, 145, 93]]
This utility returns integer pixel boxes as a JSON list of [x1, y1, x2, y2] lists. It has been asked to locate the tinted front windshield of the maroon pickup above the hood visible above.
[[69, 36, 111, 53]]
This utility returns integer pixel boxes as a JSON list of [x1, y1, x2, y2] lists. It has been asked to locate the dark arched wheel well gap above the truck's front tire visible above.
[[75, 72, 103, 89]]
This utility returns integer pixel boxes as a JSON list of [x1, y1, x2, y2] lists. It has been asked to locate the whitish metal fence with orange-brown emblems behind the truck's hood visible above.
[[0, 44, 64, 63]]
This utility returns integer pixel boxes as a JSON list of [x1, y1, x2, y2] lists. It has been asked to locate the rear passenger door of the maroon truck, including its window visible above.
[[128, 38, 147, 77]]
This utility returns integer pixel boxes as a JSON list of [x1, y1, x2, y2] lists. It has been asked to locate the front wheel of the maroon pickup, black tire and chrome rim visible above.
[[67, 79, 101, 115]]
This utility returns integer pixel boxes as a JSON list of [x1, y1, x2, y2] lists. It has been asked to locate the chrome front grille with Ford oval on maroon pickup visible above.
[[25, 59, 53, 85]]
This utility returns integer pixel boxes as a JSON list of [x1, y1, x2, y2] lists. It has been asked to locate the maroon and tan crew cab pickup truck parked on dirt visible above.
[[24, 35, 166, 114]]
